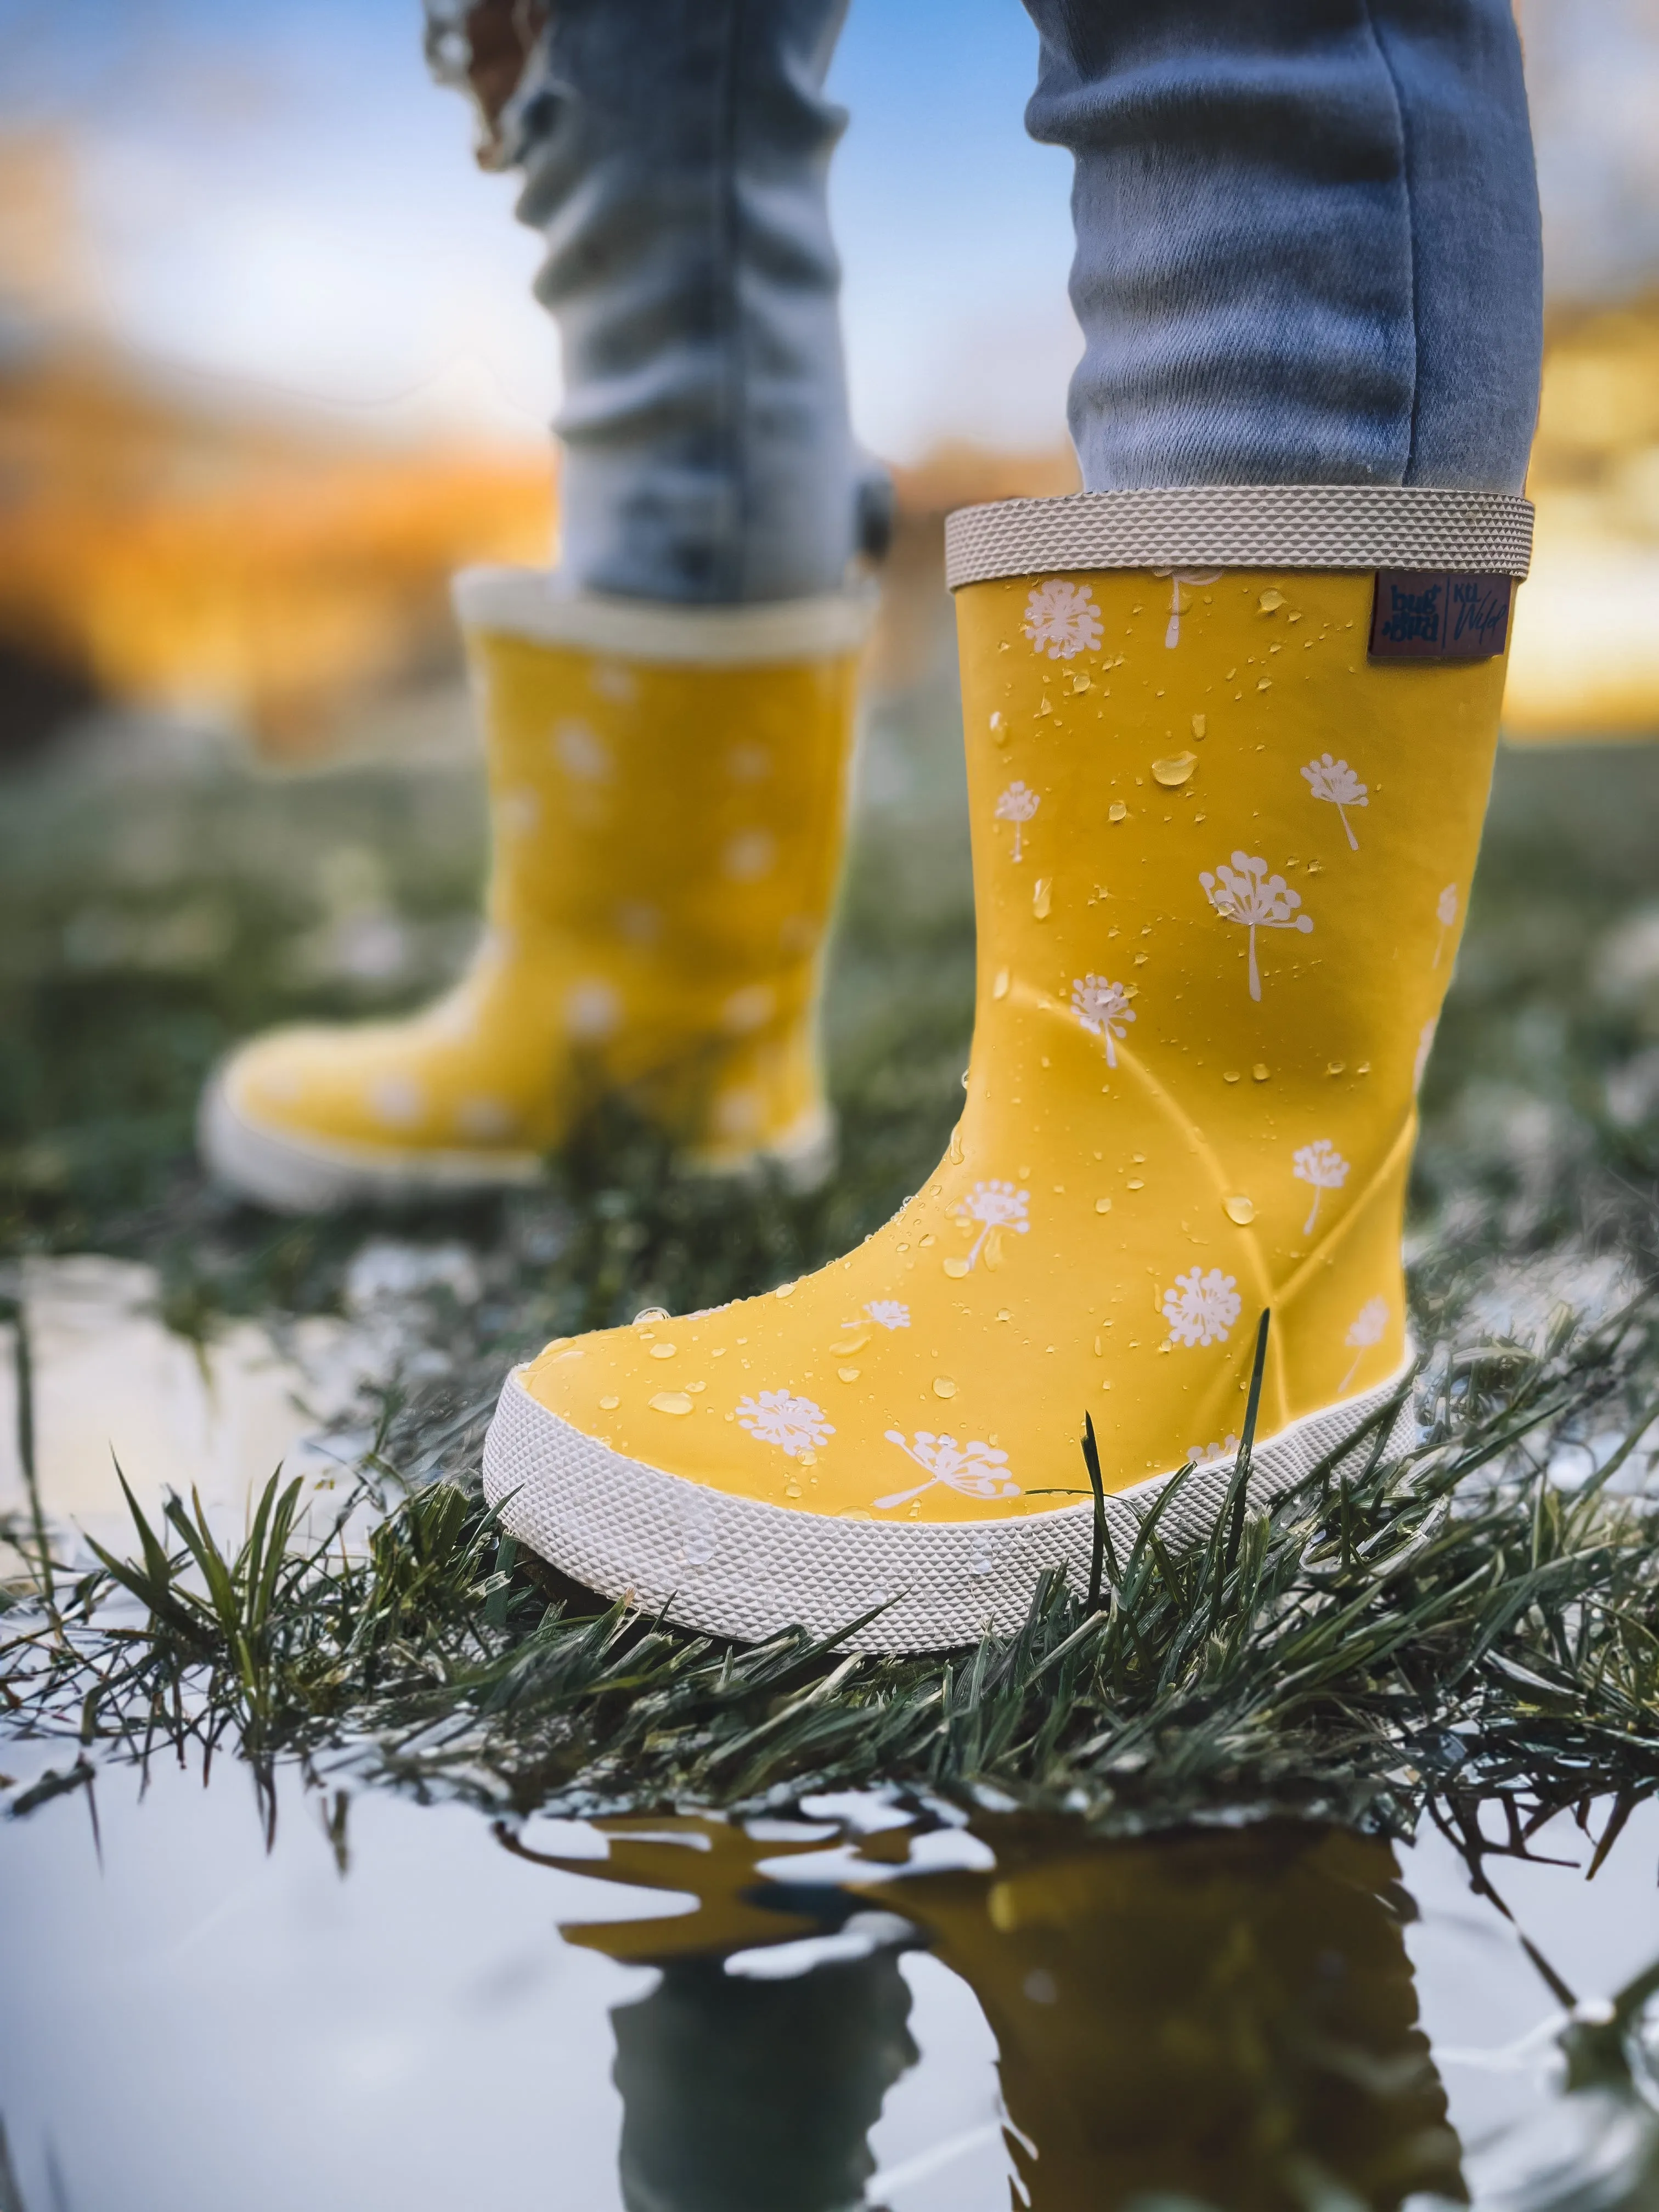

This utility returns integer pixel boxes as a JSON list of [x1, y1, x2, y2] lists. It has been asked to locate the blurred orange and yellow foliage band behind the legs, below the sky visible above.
[[0, 123, 1659, 757]]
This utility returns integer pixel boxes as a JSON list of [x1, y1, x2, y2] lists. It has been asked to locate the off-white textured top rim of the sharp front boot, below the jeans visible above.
[[945, 484, 1533, 591]]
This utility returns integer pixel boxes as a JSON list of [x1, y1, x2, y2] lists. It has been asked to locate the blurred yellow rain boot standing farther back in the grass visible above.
[[201, 568, 870, 1210]]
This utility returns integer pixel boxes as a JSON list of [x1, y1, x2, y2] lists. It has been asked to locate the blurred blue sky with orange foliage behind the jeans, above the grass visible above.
[[0, 0, 1659, 759]]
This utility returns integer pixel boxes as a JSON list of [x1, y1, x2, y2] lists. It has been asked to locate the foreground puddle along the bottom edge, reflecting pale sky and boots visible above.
[[0, 1745, 1659, 2212]]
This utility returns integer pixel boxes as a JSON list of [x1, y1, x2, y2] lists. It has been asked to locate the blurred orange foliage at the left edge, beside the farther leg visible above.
[[0, 336, 553, 754]]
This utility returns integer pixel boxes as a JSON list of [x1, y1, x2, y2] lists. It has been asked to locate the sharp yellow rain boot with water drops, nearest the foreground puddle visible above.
[[484, 487, 1531, 1650]]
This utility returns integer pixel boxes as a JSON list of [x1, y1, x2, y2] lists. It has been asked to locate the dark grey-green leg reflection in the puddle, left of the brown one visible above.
[[611, 1951, 916, 2212]]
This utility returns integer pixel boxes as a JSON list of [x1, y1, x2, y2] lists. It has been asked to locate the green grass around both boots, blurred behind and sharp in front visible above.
[[0, 690, 1659, 1841]]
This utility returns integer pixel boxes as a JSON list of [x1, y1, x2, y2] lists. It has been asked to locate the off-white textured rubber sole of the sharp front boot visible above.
[[484, 1367, 1415, 1652]]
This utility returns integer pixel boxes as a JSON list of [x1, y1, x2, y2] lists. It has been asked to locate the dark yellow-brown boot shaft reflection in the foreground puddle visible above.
[[881, 1822, 1464, 2212]]
